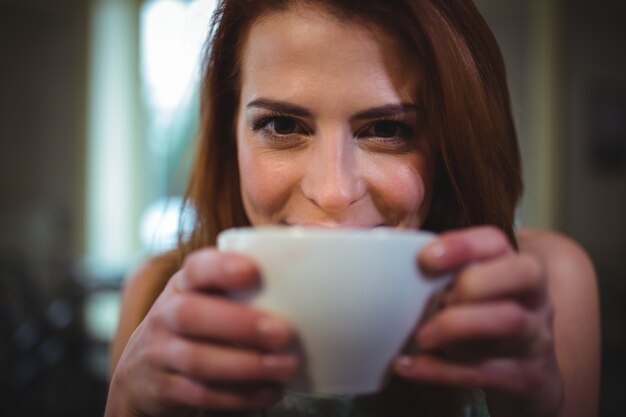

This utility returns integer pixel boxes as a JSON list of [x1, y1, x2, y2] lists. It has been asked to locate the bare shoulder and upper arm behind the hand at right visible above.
[[519, 229, 600, 417]]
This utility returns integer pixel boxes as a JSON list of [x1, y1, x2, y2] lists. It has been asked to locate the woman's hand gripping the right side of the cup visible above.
[[395, 227, 563, 417]]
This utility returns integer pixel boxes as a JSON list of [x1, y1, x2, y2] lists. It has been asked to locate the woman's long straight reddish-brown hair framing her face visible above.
[[181, 0, 522, 254]]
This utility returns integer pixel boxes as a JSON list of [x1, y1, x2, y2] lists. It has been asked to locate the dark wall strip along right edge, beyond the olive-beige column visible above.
[[561, 0, 626, 416]]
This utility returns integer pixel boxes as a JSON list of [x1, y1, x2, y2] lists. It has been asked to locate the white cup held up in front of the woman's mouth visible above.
[[218, 227, 451, 395]]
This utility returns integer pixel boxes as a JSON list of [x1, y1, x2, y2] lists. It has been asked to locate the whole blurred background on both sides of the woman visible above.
[[0, 0, 626, 417]]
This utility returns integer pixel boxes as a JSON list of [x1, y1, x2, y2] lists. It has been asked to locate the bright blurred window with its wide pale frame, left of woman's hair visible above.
[[85, 0, 215, 280]]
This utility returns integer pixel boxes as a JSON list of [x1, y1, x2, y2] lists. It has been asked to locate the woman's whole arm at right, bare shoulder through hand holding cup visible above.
[[396, 227, 599, 417]]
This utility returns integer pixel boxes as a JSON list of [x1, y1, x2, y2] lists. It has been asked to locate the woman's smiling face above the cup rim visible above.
[[236, 8, 432, 228]]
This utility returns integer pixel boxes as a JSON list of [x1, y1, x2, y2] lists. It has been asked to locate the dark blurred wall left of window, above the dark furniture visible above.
[[0, 0, 86, 293]]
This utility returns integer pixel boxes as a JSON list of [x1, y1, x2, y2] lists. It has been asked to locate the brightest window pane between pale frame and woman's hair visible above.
[[140, 0, 215, 252]]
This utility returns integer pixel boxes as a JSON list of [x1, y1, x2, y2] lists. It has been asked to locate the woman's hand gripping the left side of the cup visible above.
[[105, 249, 297, 417]]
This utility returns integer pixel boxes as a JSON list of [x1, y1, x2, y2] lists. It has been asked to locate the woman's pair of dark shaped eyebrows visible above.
[[246, 98, 423, 120]]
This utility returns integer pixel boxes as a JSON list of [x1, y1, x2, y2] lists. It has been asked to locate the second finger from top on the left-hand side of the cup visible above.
[[161, 293, 294, 350]]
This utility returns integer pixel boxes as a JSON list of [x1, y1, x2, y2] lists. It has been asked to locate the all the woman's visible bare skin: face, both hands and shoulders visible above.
[[106, 5, 599, 417]]
